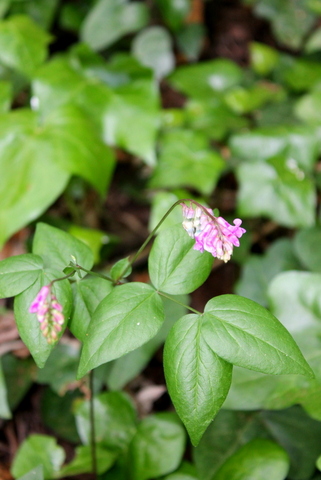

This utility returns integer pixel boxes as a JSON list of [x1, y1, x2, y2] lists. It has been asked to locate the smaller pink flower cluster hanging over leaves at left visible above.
[[29, 285, 64, 344]]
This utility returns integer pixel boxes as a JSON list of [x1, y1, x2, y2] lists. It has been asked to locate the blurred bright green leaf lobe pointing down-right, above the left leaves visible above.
[[40, 105, 115, 195]]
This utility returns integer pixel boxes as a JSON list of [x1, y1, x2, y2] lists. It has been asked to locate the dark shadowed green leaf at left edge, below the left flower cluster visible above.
[[1, 353, 37, 411]]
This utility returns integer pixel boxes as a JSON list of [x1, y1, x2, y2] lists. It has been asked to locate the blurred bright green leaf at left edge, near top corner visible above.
[[0, 15, 51, 76]]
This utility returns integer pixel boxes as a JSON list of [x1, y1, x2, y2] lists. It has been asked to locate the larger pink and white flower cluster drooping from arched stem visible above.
[[181, 203, 246, 262]]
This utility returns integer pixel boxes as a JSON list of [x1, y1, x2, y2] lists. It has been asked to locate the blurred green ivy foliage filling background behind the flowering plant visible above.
[[0, 0, 321, 480]]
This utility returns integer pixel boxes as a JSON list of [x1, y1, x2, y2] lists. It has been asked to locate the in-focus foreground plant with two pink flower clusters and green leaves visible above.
[[0, 199, 313, 476]]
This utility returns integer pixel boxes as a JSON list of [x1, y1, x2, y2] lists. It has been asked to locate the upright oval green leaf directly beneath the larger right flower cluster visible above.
[[148, 225, 213, 295]]
